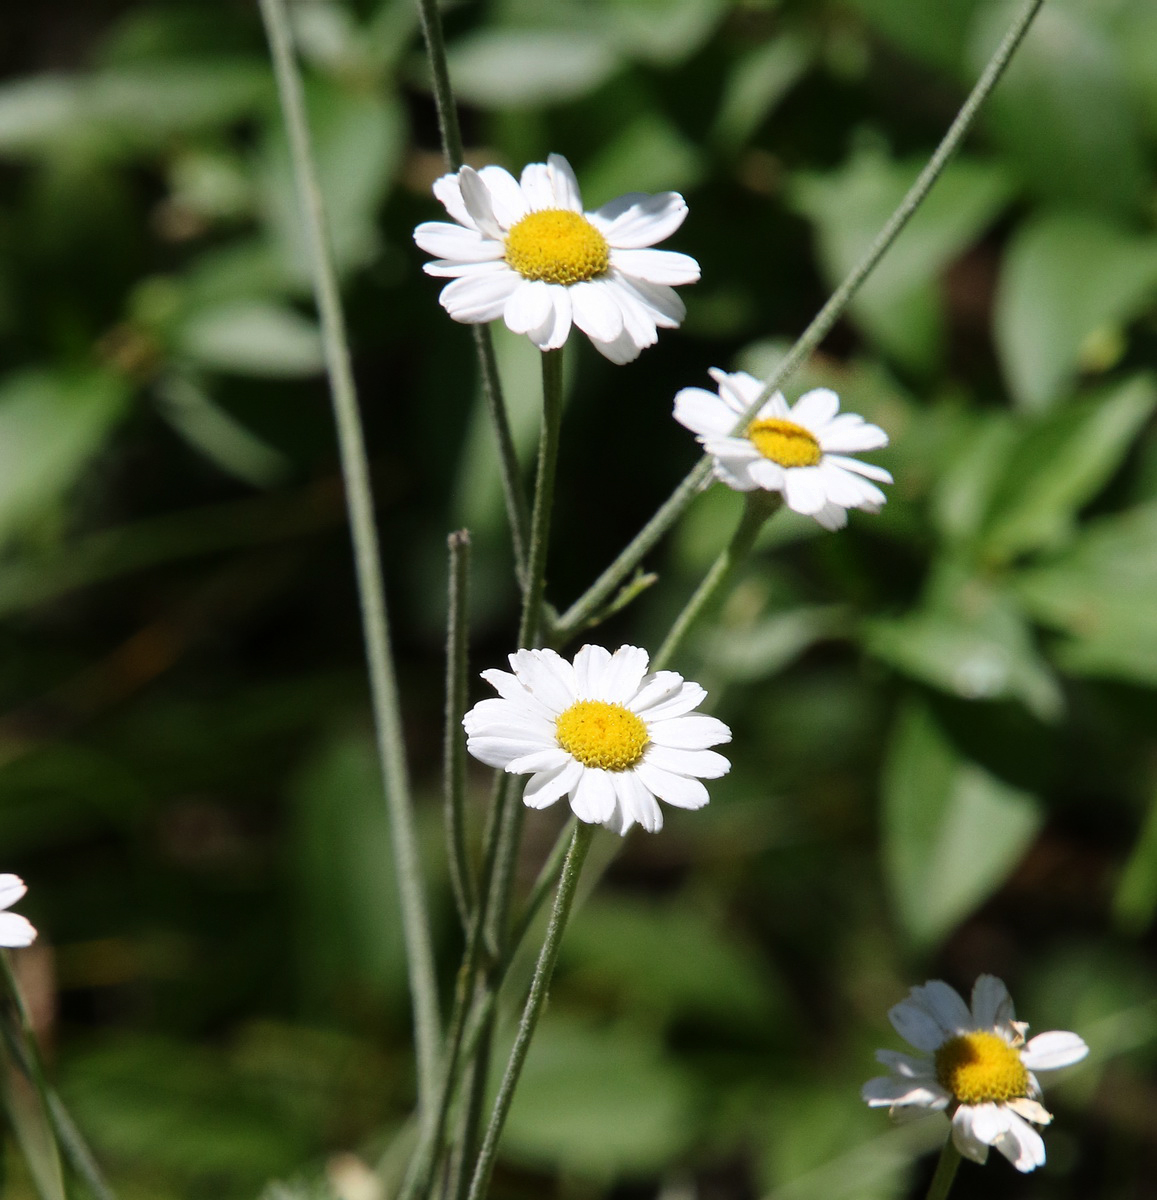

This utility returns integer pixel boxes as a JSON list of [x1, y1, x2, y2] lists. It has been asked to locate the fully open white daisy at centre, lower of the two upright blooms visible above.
[[462, 646, 731, 834]]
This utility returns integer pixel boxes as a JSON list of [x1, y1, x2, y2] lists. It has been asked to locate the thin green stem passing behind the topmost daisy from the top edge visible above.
[[418, 0, 529, 586]]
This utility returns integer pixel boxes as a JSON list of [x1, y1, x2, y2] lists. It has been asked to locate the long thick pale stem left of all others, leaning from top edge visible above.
[[259, 0, 440, 1122]]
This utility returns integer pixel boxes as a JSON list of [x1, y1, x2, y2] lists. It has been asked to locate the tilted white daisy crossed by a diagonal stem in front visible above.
[[675, 367, 892, 529]]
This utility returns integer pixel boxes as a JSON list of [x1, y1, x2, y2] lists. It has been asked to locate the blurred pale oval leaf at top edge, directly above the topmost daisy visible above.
[[449, 29, 622, 108]]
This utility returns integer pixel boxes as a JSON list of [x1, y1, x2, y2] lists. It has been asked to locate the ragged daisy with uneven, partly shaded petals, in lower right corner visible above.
[[861, 976, 1089, 1171]]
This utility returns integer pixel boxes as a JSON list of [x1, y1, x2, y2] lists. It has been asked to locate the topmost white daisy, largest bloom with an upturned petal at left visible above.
[[414, 154, 699, 362]]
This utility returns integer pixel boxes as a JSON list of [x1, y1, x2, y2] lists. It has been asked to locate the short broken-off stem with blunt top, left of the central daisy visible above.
[[442, 529, 475, 930]]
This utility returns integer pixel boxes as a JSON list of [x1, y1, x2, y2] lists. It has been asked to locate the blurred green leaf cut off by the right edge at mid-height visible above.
[[1013, 504, 1157, 684]]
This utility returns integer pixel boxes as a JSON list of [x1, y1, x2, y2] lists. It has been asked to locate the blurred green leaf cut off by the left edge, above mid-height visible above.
[[0, 371, 130, 542]]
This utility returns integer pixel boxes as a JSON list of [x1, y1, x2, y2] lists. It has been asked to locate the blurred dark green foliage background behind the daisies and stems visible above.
[[0, 0, 1157, 1200]]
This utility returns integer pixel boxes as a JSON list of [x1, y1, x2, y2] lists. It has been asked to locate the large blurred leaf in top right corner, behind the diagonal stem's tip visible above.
[[972, 0, 1147, 214]]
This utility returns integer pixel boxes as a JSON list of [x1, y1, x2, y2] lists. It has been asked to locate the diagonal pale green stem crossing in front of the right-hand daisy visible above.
[[556, 0, 1044, 640]]
